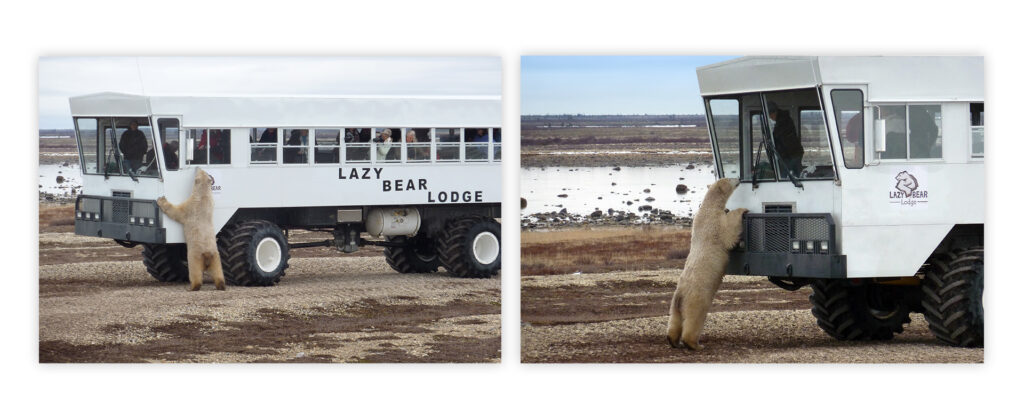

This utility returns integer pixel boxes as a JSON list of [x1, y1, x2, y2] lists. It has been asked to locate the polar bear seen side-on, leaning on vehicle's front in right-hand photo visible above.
[[669, 178, 746, 350]]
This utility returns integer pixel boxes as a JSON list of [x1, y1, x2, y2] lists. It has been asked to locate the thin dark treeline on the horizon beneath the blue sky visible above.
[[519, 114, 708, 128]]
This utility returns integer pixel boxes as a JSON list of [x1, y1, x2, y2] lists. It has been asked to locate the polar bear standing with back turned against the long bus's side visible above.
[[157, 169, 224, 291]]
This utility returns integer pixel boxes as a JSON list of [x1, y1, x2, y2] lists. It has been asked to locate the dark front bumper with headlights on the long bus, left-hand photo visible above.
[[75, 196, 167, 244]]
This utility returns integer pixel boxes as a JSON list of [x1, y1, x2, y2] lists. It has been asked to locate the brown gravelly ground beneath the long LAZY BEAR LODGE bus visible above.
[[39, 203, 501, 363]]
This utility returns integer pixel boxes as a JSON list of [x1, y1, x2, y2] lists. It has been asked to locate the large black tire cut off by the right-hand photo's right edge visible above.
[[921, 246, 985, 347]]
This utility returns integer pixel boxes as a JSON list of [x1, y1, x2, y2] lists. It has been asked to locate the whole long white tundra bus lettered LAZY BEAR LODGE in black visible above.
[[71, 93, 502, 286]]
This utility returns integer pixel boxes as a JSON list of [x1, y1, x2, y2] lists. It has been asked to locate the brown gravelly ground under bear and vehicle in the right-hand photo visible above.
[[521, 269, 984, 363]]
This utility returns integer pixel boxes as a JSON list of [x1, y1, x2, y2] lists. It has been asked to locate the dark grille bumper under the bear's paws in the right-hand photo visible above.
[[726, 213, 846, 279]]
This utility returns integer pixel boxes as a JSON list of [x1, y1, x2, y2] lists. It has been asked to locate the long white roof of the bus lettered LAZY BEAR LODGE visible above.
[[70, 92, 502, 128]]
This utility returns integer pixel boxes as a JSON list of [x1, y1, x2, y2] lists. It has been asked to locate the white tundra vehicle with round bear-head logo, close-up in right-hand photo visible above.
[[697, 56, 985, 346]]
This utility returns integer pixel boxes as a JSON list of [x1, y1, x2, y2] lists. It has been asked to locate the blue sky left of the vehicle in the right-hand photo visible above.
[[520, 55, 735, 115]]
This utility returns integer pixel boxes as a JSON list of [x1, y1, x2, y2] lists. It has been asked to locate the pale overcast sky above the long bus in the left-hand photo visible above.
[[39, 57, 502, 129]]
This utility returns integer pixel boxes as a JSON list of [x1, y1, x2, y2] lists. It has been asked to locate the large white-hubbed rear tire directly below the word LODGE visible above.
[[437, 216, 502, 278]]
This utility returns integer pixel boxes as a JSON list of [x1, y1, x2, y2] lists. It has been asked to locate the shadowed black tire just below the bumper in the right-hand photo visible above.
[[811, 279, 910, 340]]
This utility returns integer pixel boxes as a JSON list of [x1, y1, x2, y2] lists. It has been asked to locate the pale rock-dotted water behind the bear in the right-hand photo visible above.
[[519, 163, 715, 216]]
